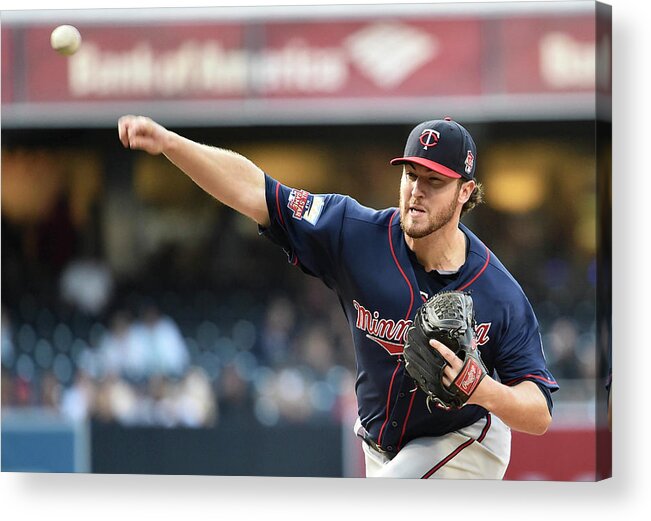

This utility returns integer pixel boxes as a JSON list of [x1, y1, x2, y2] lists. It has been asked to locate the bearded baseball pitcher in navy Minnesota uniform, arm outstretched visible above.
[[118, 116, 558, 479]]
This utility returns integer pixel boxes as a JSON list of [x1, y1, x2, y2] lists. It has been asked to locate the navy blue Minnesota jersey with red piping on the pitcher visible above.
[[261, 176, 558, 452]]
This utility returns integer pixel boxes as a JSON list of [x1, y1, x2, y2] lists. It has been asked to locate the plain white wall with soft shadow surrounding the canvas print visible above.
[[0, 0, 651, 521]]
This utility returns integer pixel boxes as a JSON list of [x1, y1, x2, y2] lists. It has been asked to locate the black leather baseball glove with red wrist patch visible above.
[[403, 291, 488, 412]]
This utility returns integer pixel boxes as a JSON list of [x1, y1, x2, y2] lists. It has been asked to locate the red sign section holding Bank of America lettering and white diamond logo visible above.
[[17, 20, 481, 102]]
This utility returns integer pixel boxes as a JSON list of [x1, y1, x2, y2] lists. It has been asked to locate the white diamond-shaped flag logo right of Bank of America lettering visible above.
[[345, 22, 439, 89]]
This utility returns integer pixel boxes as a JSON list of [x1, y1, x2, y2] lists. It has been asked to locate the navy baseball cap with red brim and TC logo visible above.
[[391, 117, 477, 180]]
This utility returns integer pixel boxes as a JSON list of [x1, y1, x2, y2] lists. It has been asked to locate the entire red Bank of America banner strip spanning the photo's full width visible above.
[[2, 12, 610, 123]]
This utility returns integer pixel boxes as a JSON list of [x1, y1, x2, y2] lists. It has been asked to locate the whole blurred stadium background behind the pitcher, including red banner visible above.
[[1, 2, 610, 481]]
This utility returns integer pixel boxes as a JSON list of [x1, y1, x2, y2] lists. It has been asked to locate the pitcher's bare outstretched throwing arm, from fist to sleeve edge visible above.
[[118, 116, 269, 226]]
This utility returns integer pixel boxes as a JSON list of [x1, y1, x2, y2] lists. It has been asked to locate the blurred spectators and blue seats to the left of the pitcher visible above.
[[2, 251, 354, 428]]
